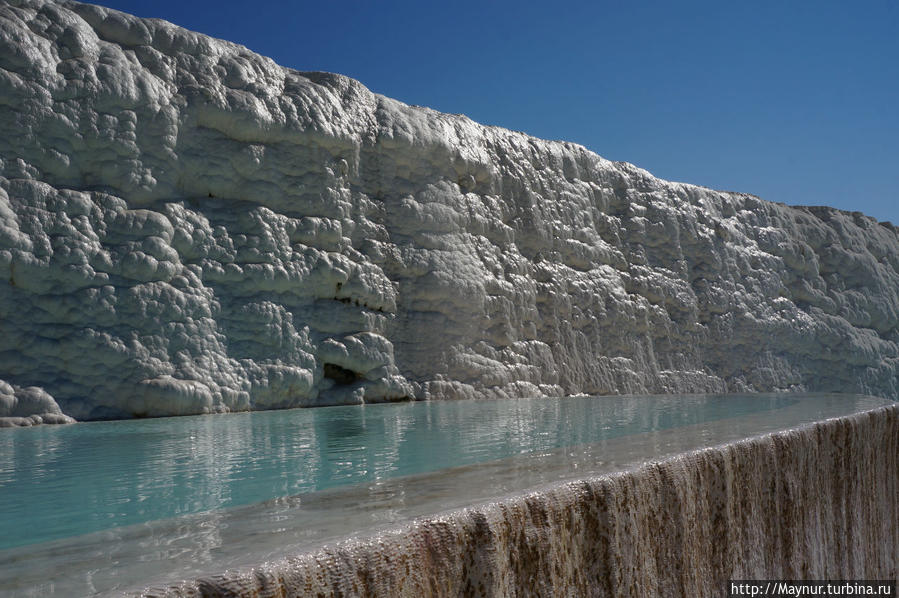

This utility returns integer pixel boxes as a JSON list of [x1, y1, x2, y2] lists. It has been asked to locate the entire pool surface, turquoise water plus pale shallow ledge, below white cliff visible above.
[[0, 394, 891, 596]]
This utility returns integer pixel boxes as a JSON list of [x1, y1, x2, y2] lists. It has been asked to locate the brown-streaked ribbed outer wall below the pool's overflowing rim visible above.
[[137, 405, 899, 596]]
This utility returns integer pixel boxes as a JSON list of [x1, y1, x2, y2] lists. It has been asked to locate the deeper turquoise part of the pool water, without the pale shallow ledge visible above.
[[0, 395, 797, 549]]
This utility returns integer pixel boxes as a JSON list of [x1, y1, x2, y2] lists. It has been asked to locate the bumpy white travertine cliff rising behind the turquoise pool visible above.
[[0, 0, 899, 419]]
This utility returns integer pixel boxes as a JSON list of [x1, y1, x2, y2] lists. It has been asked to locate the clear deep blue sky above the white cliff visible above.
[[95, 0, 899, 225]]
